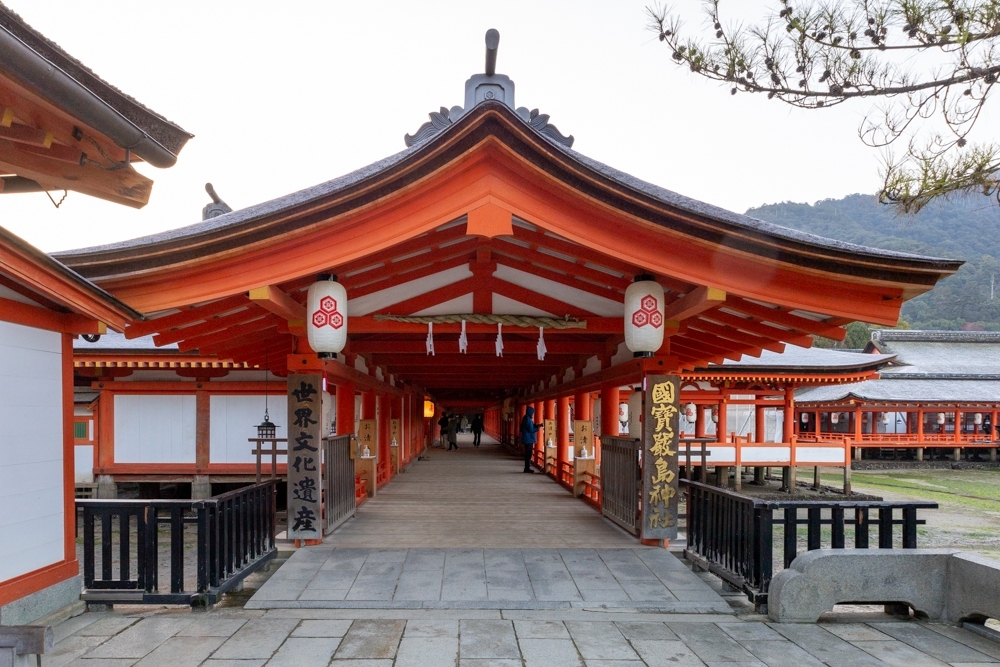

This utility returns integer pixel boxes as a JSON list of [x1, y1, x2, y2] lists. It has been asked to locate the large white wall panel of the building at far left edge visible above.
[[0, 321, 64, 583]]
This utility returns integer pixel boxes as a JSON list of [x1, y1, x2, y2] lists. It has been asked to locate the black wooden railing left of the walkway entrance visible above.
[[77, 480, 277, 607]]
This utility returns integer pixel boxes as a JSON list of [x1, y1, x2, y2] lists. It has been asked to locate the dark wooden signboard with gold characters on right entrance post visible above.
[[639, 375, 680, 540]]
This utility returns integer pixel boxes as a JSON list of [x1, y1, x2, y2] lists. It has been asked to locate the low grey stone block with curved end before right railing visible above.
[[768, 549, 956, 623]]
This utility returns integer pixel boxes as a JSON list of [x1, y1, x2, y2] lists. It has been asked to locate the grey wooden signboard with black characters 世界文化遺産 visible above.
[[288, 373, 323, 540]]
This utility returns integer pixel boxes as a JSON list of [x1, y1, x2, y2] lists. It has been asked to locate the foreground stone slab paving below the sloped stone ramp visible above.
[[43, 609, 1000, 667]]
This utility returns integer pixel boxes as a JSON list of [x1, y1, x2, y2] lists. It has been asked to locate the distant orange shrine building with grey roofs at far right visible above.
[[796, 331, 1000, 462]]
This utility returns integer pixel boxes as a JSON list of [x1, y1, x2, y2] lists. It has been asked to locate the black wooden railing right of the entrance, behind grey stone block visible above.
[[681, 480, 938, 609]]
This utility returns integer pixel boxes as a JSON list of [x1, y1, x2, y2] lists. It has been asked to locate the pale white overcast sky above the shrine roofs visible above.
[[0, 0, 989, 251]]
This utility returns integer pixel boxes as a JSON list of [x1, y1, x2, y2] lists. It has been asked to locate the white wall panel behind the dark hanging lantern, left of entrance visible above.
[[208, 394, 288, 464]]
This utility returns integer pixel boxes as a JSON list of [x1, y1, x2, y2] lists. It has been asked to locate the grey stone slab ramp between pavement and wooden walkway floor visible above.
[[246, 546, 731, 614]]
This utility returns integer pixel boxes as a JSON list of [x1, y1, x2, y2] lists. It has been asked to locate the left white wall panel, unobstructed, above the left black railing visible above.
[[115, 394, 196, 463]]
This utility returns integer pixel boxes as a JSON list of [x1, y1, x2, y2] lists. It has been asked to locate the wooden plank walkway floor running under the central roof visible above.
[[324, 435, 639, 548]]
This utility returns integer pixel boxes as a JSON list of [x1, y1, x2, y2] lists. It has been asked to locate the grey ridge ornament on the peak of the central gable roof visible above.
[[403, 28, 573, 148]]
